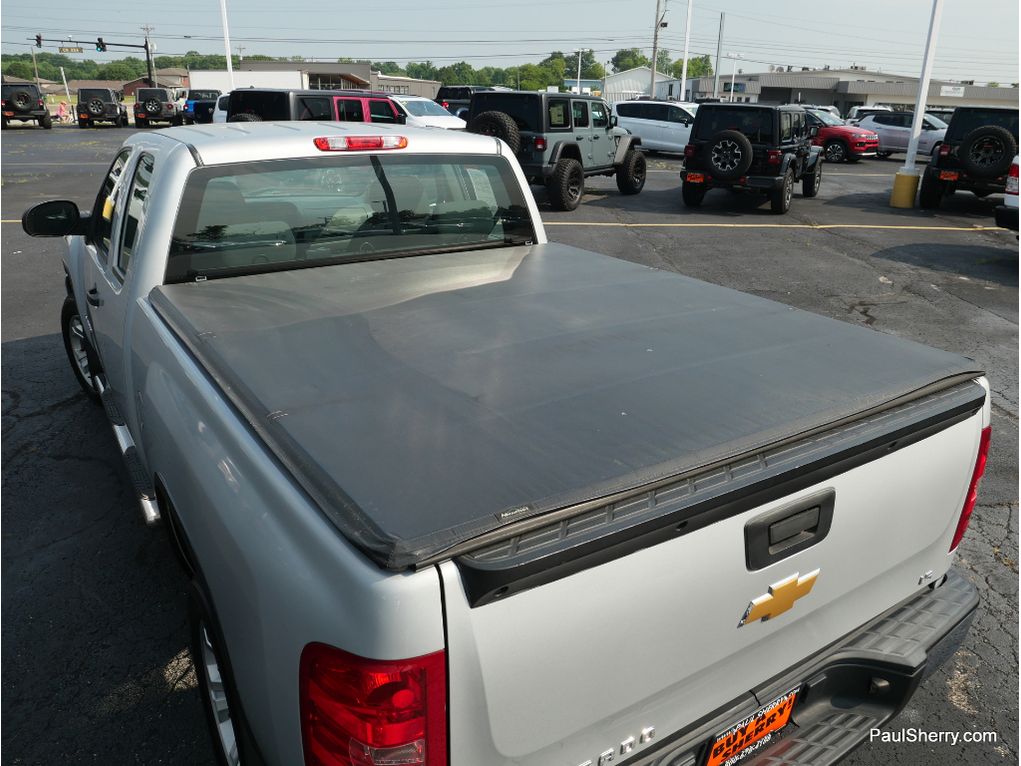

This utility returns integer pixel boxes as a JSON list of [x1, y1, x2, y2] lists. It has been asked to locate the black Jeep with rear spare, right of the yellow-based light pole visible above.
[[918, 106, 1018, 210]]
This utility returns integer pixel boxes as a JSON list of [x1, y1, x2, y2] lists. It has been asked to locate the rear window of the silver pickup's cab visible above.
[[166, 154, 535, 282]]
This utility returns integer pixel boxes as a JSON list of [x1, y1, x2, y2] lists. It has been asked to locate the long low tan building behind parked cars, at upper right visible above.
[[655, 66, 1019, 114]]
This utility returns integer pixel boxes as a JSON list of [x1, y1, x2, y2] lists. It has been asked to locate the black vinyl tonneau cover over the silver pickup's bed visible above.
[[151, 244, 981, 569]]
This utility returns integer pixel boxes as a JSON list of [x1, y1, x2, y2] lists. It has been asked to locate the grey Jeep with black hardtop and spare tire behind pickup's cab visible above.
[[468, 91, 645, 210]]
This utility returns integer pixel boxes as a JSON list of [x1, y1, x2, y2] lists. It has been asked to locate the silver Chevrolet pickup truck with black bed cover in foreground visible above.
[[22, 123, 989, 766]]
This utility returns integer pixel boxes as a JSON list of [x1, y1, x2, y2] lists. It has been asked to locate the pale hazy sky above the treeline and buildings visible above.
[[0, 0, 1019, 85]]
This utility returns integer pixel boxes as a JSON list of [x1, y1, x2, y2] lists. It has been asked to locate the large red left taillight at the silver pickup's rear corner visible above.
[[298, 643, 447, 766]]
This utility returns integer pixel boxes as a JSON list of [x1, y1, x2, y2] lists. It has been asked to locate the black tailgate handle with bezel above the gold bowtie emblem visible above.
[[744, 489, 836, 571]]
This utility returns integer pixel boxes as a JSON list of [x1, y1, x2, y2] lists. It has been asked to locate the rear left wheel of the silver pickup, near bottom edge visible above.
[[189, 581, 263, 766]]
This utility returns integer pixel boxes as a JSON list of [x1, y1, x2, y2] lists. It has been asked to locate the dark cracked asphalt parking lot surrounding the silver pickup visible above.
[[0, 127, 1018, 766]]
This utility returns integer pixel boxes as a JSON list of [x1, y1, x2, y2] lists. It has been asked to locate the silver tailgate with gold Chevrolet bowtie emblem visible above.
[[439, 384, 985, 766]]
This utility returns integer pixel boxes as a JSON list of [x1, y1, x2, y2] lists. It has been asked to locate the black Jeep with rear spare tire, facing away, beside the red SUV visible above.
[[681, 104, 823, 213]]
